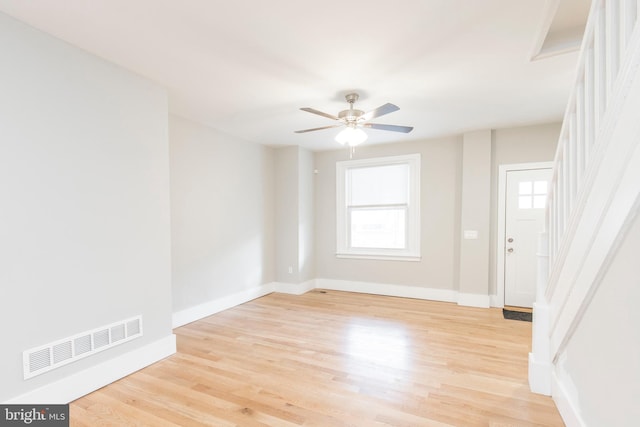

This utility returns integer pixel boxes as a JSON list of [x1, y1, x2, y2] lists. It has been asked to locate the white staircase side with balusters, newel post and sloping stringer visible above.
[[529, 0, 640, 425]]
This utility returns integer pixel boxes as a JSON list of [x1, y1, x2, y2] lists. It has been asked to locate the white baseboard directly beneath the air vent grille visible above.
[[5, 334, 176, 405]]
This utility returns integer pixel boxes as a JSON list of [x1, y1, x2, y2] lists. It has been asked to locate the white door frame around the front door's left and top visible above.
[[495, 162, 553, 307]]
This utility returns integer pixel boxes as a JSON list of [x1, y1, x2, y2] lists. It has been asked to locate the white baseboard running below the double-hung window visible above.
[[315, 279, 456, 302]]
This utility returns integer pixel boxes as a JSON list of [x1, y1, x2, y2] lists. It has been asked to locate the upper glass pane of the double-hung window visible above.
[[347, 164, 409, 206]]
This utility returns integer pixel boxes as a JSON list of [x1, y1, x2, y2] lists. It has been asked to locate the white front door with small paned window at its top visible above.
[[504, 169, 551, 307]]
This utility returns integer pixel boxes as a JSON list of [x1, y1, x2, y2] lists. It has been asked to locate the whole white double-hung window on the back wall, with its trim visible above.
[[336, 154, 420, 260]]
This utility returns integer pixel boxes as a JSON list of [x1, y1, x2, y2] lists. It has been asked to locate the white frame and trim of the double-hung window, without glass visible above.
[[336, 154, 421, 261]]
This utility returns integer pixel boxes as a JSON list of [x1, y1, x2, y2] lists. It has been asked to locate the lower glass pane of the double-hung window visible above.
[[350, 208, 407, 249]]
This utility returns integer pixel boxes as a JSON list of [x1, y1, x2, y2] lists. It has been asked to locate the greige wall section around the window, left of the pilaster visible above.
[[315, 136, 462, 290]]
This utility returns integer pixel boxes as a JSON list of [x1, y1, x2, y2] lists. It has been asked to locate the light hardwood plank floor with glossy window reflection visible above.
[[70, 290, 563, 427]]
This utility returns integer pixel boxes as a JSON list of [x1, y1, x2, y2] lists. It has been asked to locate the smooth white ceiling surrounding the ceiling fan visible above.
[[0, 0, 582, 150]]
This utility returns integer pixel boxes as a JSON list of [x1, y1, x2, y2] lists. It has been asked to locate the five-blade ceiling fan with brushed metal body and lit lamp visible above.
[[295, 93, 413, 147]]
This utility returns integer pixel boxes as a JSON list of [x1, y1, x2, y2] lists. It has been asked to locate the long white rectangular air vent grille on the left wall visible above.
[[22, 316, 142, 380]]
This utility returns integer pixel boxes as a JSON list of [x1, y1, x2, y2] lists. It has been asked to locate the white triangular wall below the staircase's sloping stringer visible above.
[[556, 211, 640, 427]]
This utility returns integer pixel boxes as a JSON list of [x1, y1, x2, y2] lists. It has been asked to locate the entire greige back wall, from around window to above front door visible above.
[[315, 123, 560, 305]]
